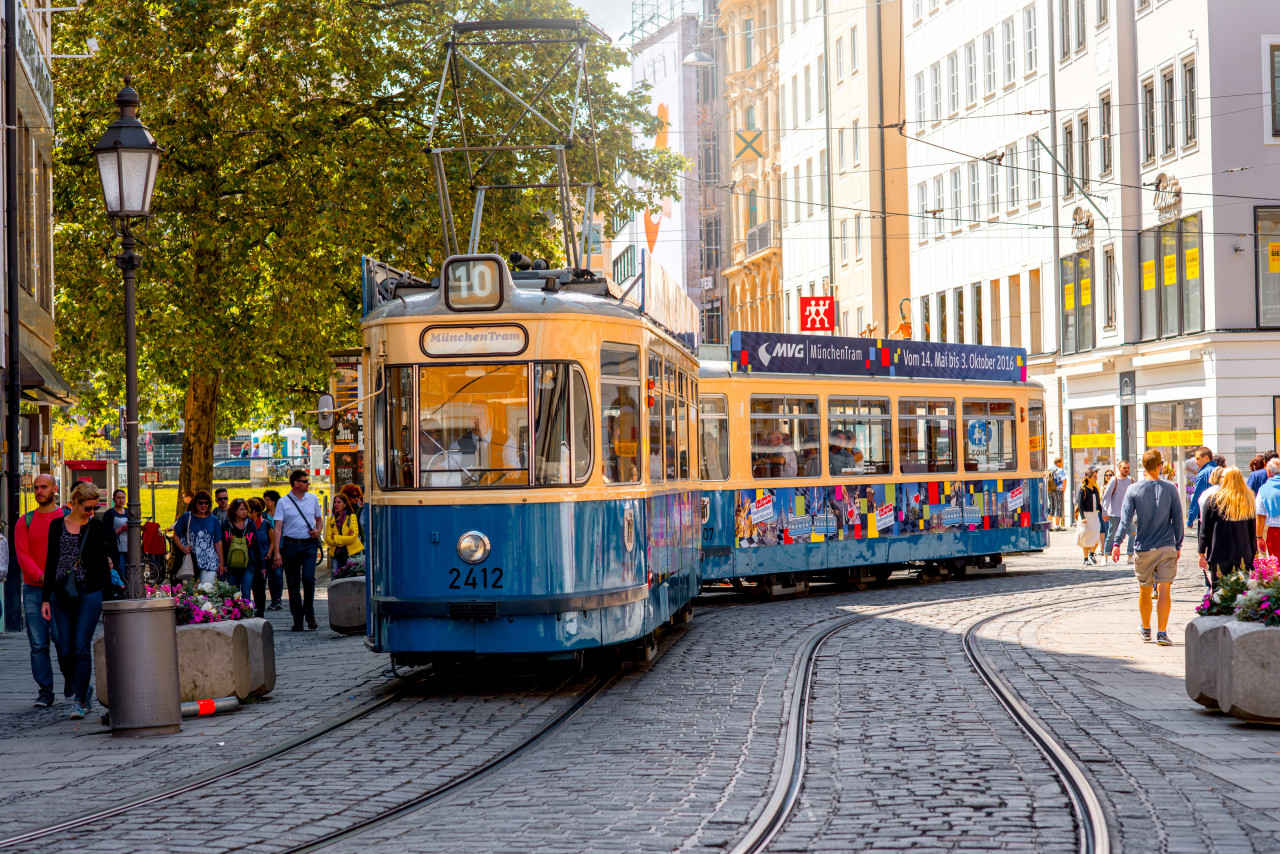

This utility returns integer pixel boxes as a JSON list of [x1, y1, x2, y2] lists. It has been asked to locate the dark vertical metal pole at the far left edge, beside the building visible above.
[[4, 0, 22, 631]]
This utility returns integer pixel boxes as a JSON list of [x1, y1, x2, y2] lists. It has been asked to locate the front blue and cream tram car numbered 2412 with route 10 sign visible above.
[[364, 255, 700, 663]]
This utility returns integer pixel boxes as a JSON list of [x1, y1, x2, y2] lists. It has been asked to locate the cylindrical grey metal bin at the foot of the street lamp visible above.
[[102, 599, 182, 736]]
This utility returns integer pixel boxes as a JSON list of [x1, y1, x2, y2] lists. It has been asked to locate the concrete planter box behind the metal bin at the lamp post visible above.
[[93, 618, 275, 707]]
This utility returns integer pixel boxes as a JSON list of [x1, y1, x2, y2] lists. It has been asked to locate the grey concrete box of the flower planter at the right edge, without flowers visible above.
[[1187, 617, 1280, 723]]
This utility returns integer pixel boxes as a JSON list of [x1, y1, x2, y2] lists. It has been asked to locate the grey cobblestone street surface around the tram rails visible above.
[[0, 533, 1280, 853]]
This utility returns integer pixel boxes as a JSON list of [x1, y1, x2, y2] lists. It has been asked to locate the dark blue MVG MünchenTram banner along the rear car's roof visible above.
[[730, 332, 1027, 383]]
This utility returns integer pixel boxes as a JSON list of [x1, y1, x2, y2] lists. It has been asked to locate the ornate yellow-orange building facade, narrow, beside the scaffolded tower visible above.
[[717, 0, 786, 339]]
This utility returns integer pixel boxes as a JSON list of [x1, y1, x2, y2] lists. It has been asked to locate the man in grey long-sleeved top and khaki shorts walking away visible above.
[[1111, 448, 1185, 647]]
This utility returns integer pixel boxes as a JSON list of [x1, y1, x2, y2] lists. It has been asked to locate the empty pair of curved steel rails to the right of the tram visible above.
[[728, 583, 1130, 854]]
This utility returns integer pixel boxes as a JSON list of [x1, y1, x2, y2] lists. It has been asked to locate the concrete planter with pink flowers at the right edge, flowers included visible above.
[[1187, 556, 1280, 723]]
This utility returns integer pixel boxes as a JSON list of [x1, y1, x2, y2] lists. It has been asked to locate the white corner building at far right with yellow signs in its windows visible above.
[[1046, 0, 1280, 507]]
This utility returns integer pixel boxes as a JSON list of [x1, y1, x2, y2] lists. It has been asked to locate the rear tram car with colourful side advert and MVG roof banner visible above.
[[699, 332, 1048, 586]]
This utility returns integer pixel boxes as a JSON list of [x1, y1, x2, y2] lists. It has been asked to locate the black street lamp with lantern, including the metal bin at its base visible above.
[[93, 77, 182, 736]]
